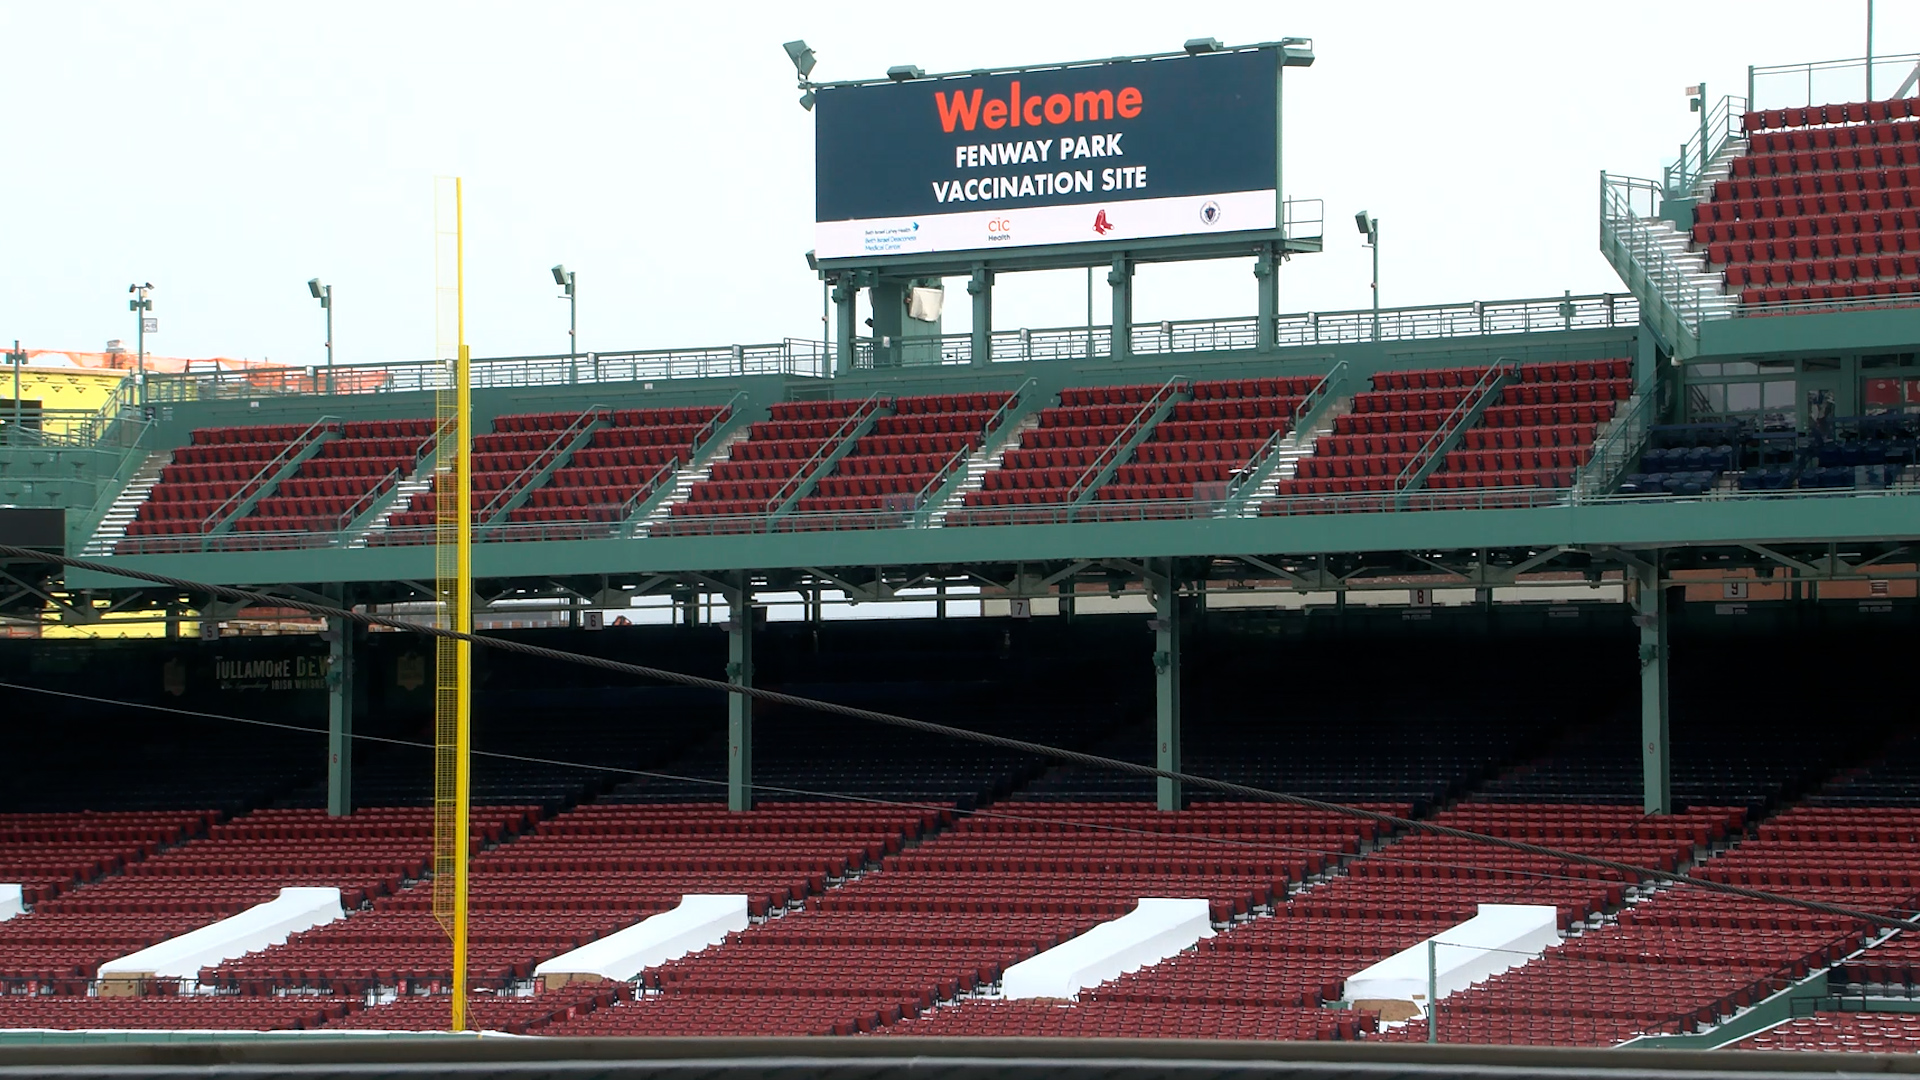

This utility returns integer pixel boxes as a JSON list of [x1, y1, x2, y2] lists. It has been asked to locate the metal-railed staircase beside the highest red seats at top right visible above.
[[1599, 173, 1734, 356]]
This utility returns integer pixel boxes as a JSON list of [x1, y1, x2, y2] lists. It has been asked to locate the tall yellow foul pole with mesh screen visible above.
[[434, 177, 474, 1032]]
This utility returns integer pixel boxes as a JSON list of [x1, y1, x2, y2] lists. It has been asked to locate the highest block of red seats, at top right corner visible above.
[[1693, 100, 1920, 304]]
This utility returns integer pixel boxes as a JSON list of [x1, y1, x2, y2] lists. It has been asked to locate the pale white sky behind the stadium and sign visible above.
[[0, 0, 1920, 363]]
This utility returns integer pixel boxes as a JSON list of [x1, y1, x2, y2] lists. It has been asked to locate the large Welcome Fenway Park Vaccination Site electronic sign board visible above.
[[814, 48, 1281, 261]]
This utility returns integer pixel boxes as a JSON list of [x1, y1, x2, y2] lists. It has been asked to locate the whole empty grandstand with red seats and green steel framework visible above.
[[0, 25, 1920, 1061]]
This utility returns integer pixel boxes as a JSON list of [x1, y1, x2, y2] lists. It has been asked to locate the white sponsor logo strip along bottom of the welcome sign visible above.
[[814, 188, 1277, 259]]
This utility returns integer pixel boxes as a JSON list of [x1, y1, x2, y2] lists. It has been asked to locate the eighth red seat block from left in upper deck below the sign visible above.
[[1094, 375, 1319, 502]]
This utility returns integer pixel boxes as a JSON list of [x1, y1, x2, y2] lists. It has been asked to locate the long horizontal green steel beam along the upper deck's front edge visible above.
[[67, 496, 1920, 588]]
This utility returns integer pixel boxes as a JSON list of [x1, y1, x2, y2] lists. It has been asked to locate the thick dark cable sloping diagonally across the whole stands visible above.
[[0, 544, 1920, 930]]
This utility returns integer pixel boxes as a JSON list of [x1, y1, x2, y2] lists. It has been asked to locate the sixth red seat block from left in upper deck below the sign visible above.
[[795, 394, 1012, 528]]
